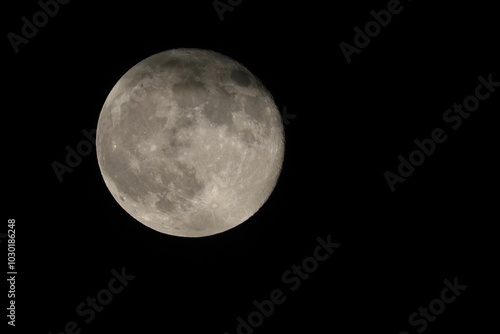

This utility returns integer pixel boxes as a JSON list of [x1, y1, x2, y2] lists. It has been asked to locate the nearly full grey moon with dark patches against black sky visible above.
[[96, 49, 285, 237]]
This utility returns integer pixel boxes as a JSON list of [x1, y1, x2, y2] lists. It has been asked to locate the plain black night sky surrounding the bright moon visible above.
[[0, 0, 500, 334]]
